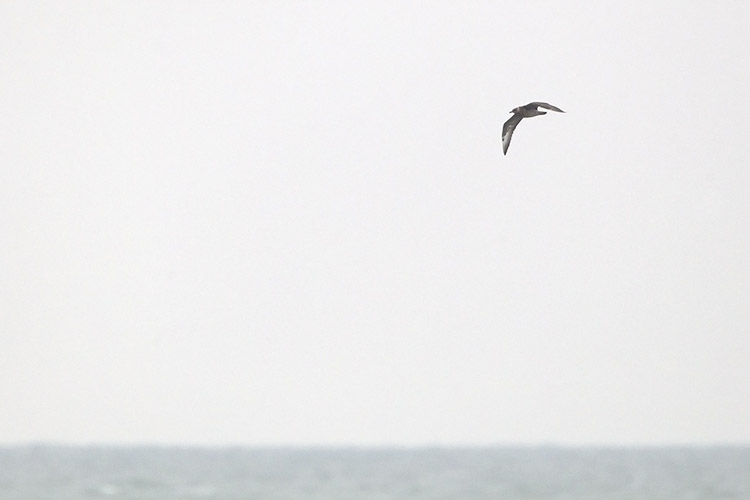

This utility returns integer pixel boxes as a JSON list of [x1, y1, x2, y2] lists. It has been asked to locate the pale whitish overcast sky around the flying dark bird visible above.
[[0, 0, 750, 445]]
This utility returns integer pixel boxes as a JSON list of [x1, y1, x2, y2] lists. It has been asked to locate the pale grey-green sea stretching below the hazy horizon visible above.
[[0, 445, 750, 500]]
